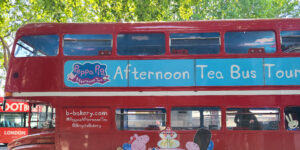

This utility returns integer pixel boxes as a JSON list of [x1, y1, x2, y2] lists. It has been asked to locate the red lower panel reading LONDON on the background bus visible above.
[[0, 128, 28, 143]]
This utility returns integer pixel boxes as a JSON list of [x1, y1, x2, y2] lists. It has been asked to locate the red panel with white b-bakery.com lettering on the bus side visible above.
[[62, 108, 110, 130]]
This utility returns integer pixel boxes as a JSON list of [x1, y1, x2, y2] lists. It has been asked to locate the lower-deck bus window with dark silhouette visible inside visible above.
[[226, 108, 280, 130]]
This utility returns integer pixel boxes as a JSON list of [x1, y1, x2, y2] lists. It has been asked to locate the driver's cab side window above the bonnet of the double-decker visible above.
[[30, 105, 56, 129]]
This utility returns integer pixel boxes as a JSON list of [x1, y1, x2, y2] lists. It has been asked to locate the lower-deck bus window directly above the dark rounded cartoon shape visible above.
[[171, 107, 221, 130]]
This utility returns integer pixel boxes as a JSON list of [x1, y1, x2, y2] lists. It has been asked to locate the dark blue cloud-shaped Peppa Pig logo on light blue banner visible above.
[[68, 63, 110, 85]]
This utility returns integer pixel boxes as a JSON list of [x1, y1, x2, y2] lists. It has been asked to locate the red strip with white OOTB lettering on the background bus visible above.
[[0, 99, 29, 112]]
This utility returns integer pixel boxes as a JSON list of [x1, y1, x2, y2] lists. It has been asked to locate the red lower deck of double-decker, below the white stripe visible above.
[[10, 95, 300, 150]]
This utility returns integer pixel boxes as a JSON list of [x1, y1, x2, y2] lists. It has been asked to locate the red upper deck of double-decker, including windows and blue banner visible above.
[[6, 19, 300, 97]]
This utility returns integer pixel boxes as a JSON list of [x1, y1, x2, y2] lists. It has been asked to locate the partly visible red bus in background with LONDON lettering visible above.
[[0, 97, 29, 144]]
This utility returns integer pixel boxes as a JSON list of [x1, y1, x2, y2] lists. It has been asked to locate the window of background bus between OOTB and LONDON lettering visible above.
[[0, 113, 28, 128]]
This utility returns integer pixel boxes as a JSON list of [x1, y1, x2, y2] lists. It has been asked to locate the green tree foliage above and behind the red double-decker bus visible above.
[[0, 0, 300, 72]]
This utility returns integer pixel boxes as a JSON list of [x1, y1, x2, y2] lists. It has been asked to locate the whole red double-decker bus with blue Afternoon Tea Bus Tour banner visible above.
[[5, 19, 300, 150]]
